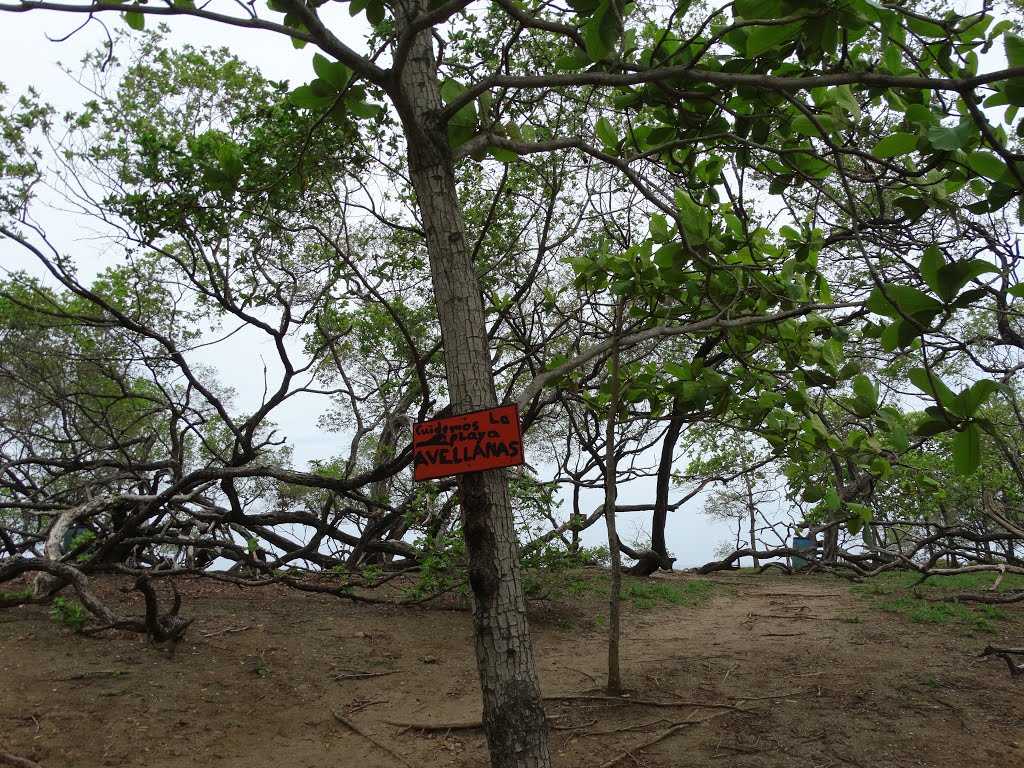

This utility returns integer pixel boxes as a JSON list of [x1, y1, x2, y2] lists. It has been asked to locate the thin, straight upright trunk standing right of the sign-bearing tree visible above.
[[604, 302, 623, 695]]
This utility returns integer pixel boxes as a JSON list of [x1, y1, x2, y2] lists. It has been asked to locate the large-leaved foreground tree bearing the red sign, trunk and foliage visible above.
[[6, 0, 1024, 766]]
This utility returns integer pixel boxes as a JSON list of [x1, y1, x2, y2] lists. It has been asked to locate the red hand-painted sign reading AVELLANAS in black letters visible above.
[[413, 404, 525, 480]]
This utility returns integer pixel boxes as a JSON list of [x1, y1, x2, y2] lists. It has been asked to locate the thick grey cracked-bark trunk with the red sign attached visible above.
[[392, 0, 551, 768]]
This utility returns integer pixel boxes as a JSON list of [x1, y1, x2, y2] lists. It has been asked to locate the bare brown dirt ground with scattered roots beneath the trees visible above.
[[0, 573, 1024, 768]]
